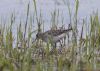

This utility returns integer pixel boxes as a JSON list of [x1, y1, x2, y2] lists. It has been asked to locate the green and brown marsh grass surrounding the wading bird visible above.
[[0, 0, 100, 71]]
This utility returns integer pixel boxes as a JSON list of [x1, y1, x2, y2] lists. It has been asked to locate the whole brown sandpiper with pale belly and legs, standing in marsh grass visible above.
[[36, 28, 72, 47]]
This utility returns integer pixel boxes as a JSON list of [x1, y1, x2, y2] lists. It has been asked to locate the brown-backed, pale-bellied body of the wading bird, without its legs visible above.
[[38, 29, 72, 42]]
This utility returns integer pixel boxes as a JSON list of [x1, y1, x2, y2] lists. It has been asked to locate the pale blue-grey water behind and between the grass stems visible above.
[[0, 0, 100, 40]]
